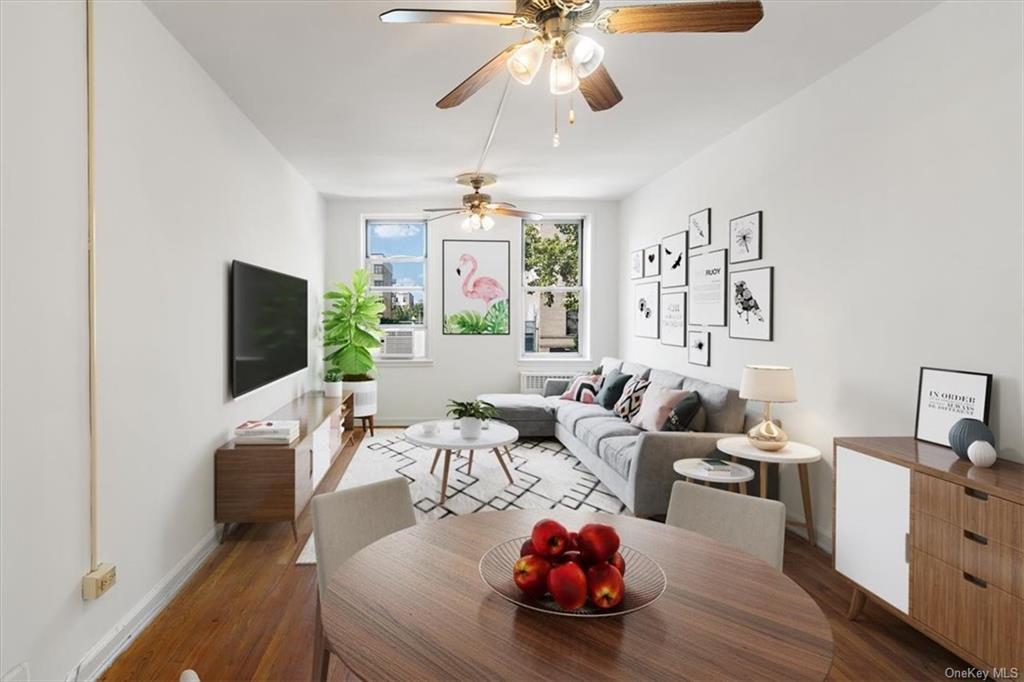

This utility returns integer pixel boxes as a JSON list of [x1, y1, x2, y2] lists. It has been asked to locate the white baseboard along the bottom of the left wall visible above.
[[67, 526, 219, 682]]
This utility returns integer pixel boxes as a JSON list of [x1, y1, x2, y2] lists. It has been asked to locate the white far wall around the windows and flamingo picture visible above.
[[326, 196, 618, 424]]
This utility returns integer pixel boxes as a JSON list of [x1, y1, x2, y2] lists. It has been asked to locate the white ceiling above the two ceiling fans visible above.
[[147, 0, 937, 199]]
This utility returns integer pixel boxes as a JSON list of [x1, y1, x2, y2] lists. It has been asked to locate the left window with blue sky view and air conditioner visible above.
[[366, 220, 427, 358]]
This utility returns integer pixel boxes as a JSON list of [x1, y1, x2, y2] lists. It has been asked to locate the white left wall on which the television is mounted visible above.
[[0, 1, 325, 680]]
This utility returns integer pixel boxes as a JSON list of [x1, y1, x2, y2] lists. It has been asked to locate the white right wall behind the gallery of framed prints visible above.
[[618, 2, 1024, 548]]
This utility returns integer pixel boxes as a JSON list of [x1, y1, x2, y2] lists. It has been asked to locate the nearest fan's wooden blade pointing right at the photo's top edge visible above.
[[594, 0, 765, 33]]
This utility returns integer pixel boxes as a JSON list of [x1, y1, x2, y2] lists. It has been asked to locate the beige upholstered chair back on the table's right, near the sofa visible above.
[[665, 480, 785, 570]]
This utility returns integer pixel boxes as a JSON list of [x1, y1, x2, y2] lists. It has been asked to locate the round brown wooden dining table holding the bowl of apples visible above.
[[322, 510, 833, 680]]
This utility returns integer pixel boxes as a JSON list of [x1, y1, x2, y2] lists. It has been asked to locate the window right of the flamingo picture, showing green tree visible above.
[[522, 219, 586, 357]]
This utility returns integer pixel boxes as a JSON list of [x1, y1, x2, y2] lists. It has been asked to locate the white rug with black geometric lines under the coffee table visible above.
[[296, 429, 630, 563]]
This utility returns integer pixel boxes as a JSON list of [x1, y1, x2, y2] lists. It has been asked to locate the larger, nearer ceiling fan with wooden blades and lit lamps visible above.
[[380, 0, 764, 112]]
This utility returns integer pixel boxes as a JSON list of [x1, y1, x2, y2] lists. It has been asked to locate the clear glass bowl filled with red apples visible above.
[[480, 518, 667, 617]]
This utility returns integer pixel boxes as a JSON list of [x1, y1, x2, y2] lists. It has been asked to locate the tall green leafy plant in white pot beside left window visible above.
[[324, 269, 384, 423]]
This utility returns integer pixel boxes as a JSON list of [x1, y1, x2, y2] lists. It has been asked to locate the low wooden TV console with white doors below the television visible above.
[[214, 391, 352, 541]]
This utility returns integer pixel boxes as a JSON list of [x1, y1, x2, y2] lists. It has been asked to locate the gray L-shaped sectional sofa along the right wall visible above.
[[479, 357, 759, 516]]
